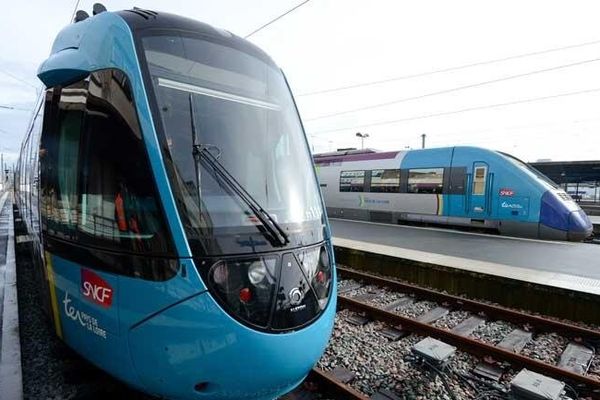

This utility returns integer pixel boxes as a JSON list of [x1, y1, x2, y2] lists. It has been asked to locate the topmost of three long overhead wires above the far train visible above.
[[295, 40, 600, 97]]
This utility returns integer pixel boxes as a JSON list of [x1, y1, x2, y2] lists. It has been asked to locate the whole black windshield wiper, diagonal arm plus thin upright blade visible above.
[[189, 93, 290, 247]]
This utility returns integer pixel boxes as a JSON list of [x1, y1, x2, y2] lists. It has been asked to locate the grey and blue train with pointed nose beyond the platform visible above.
[[314, 147, 592, 241]]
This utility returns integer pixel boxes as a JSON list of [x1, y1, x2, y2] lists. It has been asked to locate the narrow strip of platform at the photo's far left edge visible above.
[[0, 192, 23, 400]]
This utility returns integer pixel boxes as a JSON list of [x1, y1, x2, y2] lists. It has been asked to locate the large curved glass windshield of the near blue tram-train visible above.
[[142, 34, 325, 255]]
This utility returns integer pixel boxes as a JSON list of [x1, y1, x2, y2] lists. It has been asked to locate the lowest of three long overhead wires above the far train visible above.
[[310, 88, 600, 135]]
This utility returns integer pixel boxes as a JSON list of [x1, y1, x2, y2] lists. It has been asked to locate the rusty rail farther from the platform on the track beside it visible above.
[[338, 295, 600, 399]]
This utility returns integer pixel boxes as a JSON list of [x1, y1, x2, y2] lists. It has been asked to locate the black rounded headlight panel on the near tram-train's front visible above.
[[198, 246, 333, 332]]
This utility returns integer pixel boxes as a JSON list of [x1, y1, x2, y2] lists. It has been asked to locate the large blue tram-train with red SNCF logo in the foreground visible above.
[[15, 9, 336, 399]]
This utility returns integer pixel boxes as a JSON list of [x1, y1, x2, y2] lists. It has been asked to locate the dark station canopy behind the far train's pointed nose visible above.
[[529, 160, 600, 184]]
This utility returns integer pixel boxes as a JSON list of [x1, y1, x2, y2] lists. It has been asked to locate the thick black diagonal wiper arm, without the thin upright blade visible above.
[[194, 145, 290, 247]]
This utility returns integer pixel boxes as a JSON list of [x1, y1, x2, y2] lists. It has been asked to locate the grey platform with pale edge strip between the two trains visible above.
[[330, 218, 600, 295]]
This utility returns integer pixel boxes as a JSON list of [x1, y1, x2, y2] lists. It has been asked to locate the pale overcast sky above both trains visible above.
[[0, 0, 600, 167]]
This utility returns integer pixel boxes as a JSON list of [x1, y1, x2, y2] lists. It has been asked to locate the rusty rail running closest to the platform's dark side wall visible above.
[[337, 266, 600, 342]]
